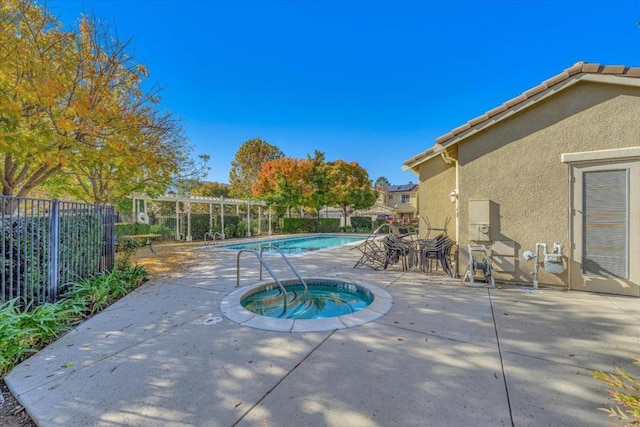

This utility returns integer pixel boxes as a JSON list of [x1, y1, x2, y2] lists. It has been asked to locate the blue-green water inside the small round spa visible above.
[[240, 279, 374, 319]]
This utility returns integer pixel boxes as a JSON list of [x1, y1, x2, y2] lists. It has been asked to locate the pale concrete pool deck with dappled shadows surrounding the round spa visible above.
[[5, 242, 640, 427]]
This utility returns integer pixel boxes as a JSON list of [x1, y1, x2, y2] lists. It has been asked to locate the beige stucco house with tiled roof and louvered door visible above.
[[403, 62, 640, 296]]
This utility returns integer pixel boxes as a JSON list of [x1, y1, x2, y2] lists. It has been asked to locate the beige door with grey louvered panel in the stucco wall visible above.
[[570, 161, 640, 296]]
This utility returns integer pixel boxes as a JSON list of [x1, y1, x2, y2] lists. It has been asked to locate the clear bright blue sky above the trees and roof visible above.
[[47, 0, 640, 184]]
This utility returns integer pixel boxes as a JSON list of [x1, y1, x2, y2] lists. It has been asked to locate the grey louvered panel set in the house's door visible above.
[[582, 169, 629, 279]]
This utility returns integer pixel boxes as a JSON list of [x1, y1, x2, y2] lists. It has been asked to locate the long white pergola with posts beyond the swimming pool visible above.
[[131, 194, 272, 242]]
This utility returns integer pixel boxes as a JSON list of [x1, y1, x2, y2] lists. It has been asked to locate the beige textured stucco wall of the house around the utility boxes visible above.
[[456, 83, 640, 286]]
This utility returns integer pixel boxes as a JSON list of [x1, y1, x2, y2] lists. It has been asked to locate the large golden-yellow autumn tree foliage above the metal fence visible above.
[[0, 0, 195, 203]]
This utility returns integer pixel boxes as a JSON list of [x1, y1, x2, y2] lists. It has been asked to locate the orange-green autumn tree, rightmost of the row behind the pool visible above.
[[327, 160, 376, 224]]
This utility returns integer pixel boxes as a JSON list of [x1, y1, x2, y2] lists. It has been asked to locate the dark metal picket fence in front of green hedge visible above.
[[0, 196, 115, 306]]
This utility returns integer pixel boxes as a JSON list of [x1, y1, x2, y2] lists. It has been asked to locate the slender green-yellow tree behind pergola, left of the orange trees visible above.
[[229, 138, 284, 198]]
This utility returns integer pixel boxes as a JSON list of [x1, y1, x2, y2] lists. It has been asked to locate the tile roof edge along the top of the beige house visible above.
[[403, 61, 640, 169]]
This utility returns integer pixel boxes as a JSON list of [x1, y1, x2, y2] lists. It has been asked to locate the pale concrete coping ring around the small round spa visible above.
[[220, 277, 393, 332]]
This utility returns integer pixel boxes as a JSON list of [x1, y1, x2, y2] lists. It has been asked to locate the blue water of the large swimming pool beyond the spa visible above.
[[224, 234, 364, 254]]
